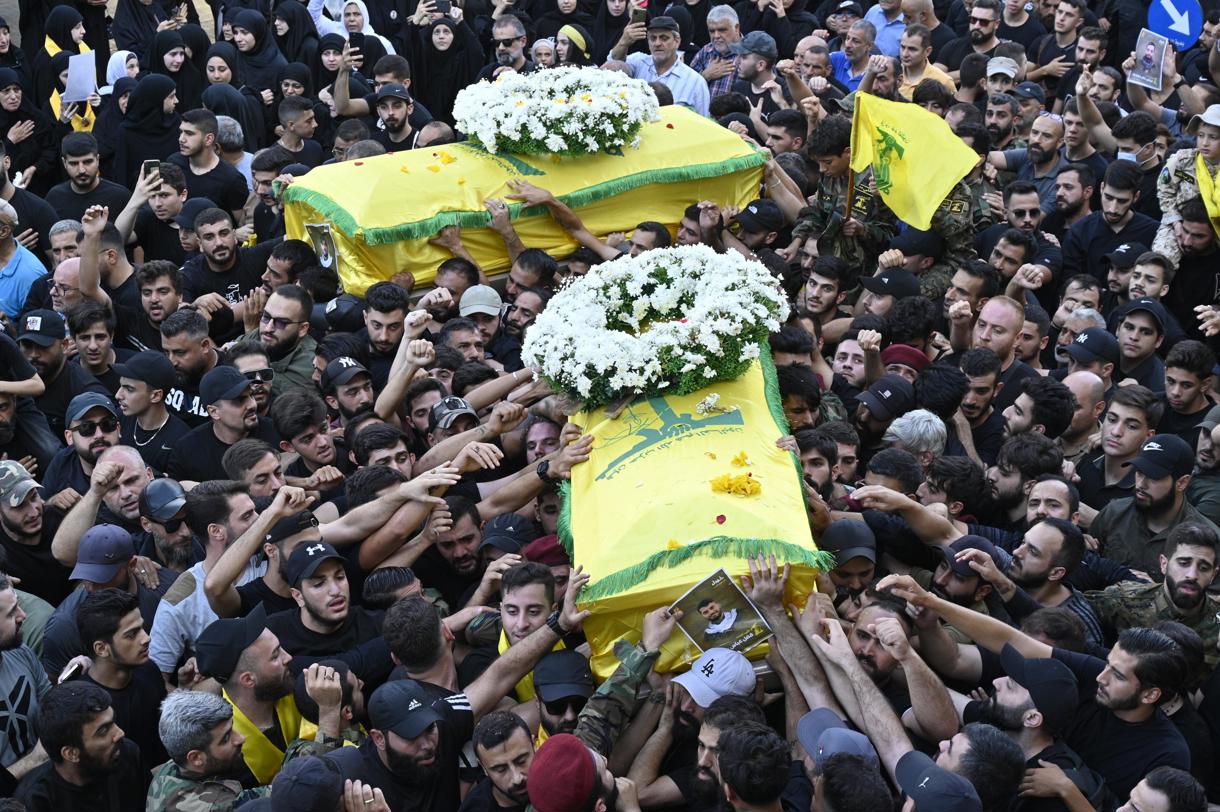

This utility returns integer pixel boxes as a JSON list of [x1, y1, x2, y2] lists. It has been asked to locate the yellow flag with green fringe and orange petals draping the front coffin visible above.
[[560, 347, 831, 679]]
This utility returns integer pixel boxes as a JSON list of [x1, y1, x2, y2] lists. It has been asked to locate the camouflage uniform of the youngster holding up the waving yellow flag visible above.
[[792, 169, 897, 276]]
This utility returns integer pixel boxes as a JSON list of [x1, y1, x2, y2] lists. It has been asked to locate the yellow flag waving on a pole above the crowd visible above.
[[852, 93, 978, 230]]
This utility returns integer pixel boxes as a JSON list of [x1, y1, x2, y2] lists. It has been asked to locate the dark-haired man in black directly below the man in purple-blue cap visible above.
[[75, 589, 166, 771]]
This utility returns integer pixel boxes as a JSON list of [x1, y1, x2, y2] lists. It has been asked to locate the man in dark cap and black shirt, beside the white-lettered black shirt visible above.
[[167, 367, 279, 482]]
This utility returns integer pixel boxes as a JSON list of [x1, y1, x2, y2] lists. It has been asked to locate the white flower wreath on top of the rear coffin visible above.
[[454, 67, 660, 155]]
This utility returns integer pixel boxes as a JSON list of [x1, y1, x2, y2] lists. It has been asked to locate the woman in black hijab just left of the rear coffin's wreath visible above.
[[407, 17, 475, 124]]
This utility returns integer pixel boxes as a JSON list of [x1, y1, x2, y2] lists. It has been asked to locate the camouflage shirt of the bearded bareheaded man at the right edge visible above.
[[1085, 580, 1220, 671]]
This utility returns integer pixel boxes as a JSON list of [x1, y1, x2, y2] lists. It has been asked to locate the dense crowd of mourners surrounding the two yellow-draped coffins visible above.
[[0, 0, 1220, 812]]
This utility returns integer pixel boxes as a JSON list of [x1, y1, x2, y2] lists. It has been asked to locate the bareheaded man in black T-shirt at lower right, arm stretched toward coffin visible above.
[[888, 575, 1191, 797]]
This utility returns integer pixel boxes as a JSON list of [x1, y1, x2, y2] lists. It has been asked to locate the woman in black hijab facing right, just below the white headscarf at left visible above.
[[115, 73, 181, 189]]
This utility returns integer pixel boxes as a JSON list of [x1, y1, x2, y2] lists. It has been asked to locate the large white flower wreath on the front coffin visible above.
[[521, 245, 788, 407]]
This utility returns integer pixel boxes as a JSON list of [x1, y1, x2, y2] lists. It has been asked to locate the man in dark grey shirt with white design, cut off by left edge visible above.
[[0, 563, 51, 794]]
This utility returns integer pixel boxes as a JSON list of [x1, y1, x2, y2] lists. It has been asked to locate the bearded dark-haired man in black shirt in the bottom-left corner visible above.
[[13, 680, 148, 812]]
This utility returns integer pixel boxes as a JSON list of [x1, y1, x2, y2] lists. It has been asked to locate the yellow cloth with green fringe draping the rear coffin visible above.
[[284, 106, 769, 294]]
